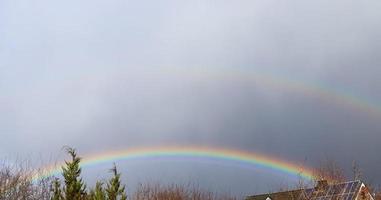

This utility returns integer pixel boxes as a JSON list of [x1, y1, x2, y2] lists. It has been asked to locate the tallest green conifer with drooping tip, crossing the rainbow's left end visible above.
[[62, 147, 86, 200]]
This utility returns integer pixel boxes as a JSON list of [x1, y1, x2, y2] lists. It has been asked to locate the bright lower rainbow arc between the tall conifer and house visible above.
[[33, 146, 314, 181]]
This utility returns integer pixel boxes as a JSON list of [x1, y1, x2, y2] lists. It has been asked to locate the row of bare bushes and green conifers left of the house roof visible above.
[[0, 147, 236, 200]]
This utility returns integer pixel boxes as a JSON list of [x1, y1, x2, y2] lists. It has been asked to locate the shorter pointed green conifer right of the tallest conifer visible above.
[[106, 164, 127, 200]]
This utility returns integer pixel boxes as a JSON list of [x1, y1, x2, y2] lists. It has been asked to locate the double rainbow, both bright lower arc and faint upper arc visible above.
[[33, 68, 381, 181]]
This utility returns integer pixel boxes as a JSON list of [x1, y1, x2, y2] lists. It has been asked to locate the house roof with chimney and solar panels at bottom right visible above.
[[246, 181, 374, 200]]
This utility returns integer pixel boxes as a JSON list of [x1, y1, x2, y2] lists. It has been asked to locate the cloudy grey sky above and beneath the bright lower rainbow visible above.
[[0, 0, 381, 195]]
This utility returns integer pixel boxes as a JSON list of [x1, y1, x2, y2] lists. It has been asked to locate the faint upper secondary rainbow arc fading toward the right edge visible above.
[[162, 68, 381, 118]]
